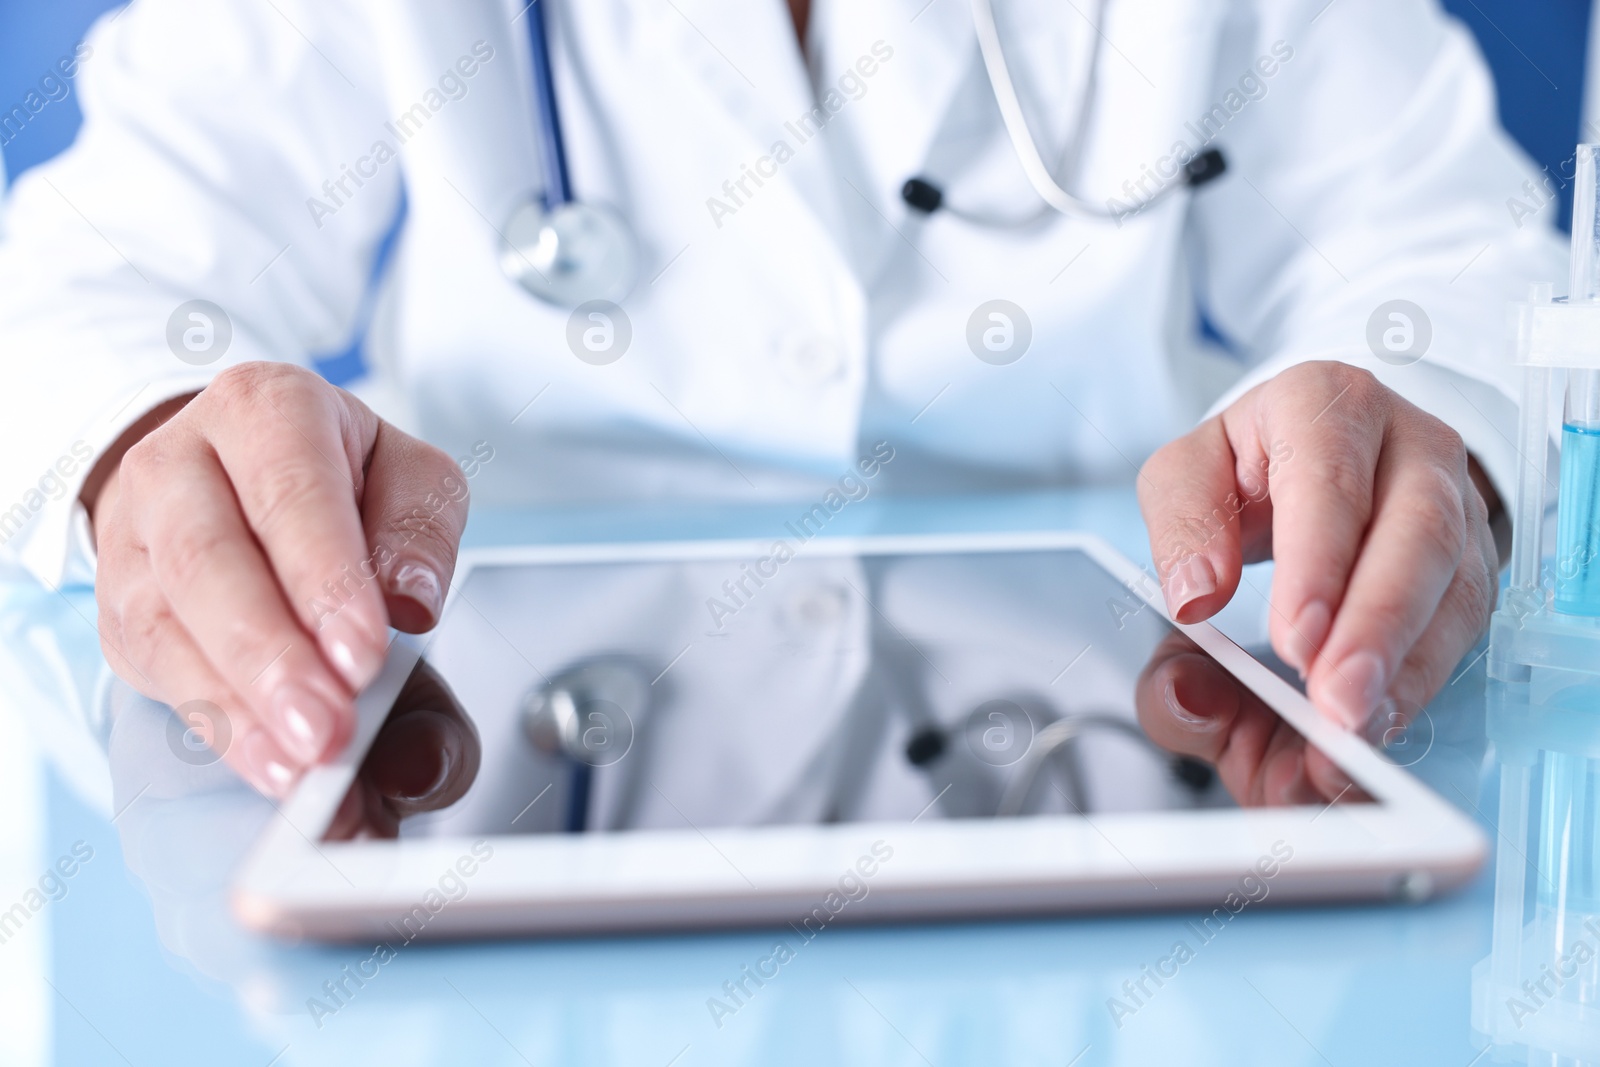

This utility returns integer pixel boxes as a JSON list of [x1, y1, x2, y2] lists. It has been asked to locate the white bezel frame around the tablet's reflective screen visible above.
[[234, 533, 1488, 942]]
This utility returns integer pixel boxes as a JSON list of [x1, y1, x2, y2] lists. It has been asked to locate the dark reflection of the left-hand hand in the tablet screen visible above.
[[328, 661, 483, 841]]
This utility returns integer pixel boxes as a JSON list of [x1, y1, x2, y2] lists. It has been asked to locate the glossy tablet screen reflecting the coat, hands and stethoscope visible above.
[[328, 542, 1365, 840]]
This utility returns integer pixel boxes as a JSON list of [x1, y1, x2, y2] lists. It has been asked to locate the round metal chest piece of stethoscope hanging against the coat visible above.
[[501, 200, 638, 307]]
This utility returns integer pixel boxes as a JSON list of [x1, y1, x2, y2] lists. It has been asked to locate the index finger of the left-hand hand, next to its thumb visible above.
[[202, 363, 389, 691]]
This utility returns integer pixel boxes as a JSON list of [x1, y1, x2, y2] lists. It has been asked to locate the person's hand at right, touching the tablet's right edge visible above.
[[1139, 363, 1499, 729]]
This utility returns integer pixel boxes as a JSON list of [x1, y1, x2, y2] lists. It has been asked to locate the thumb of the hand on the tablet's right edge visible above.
[[1139, 418, 1245, 622]]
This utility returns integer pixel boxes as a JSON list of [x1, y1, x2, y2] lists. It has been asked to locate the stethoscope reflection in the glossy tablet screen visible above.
[[522, 656, 1214, 833]]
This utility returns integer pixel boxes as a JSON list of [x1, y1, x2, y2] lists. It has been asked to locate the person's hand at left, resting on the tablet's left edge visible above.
[[85, 363, 467, 797]]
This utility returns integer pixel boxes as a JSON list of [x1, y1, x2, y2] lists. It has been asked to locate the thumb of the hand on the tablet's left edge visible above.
[[362, 422, 467, 633]]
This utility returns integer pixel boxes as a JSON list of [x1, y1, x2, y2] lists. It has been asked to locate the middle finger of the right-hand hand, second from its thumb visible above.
[[1307, 427, 1482, 729]]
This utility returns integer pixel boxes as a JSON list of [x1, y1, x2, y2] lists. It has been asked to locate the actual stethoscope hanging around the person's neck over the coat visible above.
[[501, 0, 1227, 307]]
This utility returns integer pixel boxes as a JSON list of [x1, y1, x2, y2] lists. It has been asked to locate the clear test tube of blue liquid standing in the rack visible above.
[[1555, 144, 1600, 616]]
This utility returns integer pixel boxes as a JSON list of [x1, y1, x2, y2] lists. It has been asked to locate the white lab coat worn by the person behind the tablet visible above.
[[0, 0, 1562, 598]]
